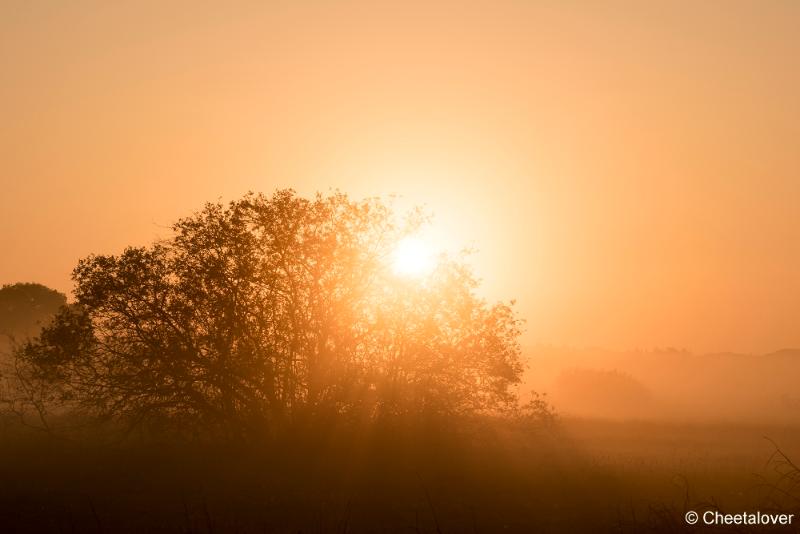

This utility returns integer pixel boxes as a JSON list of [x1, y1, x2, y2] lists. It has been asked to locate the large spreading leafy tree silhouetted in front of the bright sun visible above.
[[16, 190, 522, 435]]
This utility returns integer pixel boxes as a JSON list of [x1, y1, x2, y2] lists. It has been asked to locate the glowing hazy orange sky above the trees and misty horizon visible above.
[[0, 0, 800, 351]]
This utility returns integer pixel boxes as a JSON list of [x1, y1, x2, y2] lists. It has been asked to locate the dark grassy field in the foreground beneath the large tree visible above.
[[0, 420, 800, 533]]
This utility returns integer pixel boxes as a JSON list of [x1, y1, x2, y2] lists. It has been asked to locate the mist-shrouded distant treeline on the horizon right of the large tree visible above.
[[524, 347, 800, 424]]
